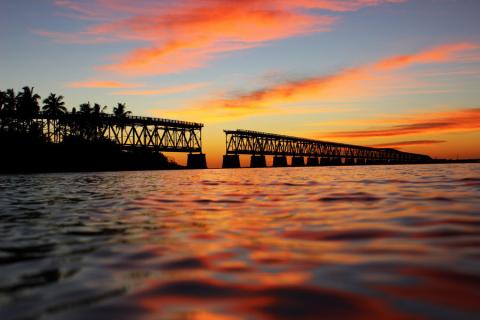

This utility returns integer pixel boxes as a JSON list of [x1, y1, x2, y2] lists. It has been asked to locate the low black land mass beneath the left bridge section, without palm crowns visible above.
[[0, 132, 180, 173]]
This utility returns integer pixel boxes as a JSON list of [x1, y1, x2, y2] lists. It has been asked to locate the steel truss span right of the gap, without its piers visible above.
[[225, 130, 431, 163]]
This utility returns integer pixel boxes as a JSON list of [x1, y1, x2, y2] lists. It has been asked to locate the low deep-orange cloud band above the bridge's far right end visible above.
[[325, 108, 480, 138]]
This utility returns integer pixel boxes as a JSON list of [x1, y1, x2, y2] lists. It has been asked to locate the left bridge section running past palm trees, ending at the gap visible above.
[[2, 112, 206, 168]]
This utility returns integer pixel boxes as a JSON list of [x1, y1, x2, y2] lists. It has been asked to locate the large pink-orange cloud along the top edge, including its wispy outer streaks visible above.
[[41, 0, 405, 75]]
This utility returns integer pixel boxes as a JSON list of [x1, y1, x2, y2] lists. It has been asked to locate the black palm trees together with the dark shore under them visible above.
[[0, 86, 181, 173]]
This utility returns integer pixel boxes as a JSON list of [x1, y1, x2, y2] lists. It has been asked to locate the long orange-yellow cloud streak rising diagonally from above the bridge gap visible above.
[[164, 43, 479, 121]]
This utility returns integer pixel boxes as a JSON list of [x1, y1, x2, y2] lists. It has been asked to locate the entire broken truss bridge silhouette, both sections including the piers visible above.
[[0, 112, 432, 169]]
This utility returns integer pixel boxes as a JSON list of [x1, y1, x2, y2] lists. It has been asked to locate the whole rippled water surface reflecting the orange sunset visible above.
[[0, 164, 480, 320]]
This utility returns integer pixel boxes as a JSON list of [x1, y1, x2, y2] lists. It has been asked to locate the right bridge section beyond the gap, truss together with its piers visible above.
[[223, 129, 432, 168]]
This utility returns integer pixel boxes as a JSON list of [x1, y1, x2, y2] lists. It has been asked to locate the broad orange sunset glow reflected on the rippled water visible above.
[[118, 166, 480, 319]]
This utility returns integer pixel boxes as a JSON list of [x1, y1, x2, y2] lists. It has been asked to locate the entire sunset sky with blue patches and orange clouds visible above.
[[0, 0, 480, 167]]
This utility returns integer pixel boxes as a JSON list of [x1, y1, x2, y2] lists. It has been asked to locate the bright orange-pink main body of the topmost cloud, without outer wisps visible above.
[[95, 1, 335, 75]]
